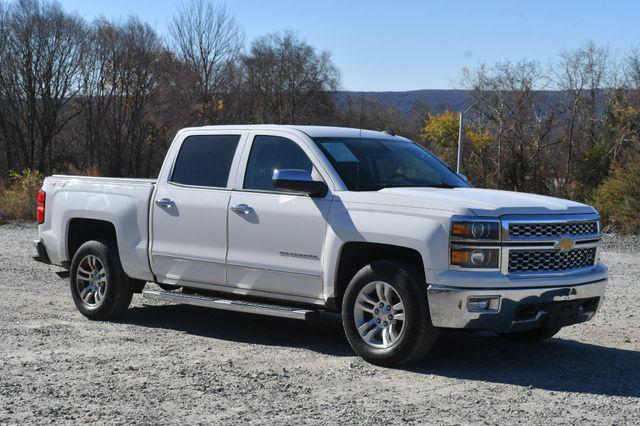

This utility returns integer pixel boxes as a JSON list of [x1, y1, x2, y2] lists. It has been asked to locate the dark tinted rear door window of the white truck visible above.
[[171, 135, 240, 188]]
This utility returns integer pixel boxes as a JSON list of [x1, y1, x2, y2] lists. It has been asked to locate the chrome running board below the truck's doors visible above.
[[142, 290, 318, 320]]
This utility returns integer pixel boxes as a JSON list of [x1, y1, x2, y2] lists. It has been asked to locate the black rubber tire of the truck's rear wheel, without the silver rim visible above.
[[70, 240, 133, 320]]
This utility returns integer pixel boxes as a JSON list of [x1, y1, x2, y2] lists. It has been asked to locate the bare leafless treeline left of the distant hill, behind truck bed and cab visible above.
[[0, 0, 339, 176]]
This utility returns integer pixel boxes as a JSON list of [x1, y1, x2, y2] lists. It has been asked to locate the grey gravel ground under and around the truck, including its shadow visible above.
[[0, 224, 640, 424]]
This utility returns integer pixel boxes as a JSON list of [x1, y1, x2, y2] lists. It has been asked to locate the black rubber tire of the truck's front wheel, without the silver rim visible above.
[[342, 261, 438, 367]]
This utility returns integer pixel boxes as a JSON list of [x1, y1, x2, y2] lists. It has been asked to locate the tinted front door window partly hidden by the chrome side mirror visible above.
[[244, 136, 313, 190]]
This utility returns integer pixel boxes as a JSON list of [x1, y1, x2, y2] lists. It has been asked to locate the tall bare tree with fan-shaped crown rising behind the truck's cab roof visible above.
[[169, 0, 244, 122]]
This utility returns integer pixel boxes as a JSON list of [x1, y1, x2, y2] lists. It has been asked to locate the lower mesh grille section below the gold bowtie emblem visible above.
[[509, 247, 596, 273]]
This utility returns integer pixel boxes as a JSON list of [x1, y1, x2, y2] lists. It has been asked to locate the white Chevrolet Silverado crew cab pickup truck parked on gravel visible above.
[[35, 125, 607, 365]]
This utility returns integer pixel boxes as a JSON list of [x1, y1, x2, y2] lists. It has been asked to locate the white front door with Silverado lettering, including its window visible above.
[[227, 135, 331, 300]]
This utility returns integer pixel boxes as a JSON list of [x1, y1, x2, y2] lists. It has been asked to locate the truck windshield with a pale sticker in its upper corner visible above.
[[314, 138, 469, 191]]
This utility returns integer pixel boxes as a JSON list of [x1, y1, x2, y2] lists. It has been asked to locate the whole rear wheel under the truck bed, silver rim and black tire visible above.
[[70, 240, 133, 320]]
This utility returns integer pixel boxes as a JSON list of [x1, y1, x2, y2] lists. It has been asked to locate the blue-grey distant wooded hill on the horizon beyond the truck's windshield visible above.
[[335, 90, 470, 114]]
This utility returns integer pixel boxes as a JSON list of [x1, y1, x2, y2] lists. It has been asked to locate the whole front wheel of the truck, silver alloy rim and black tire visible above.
[[342, 261, 438, 366]]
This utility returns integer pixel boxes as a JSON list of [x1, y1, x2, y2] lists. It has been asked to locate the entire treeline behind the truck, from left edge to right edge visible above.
[[0, 0, 640, 232]]
